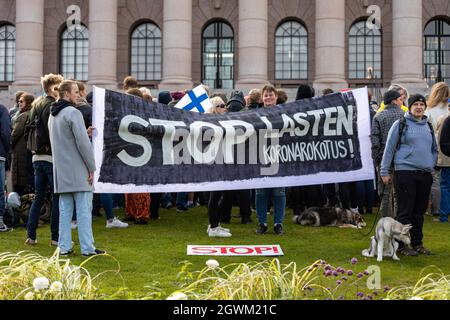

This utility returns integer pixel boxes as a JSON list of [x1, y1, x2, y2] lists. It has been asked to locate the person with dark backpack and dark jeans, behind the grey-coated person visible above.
[[25, 74, 64, 246]]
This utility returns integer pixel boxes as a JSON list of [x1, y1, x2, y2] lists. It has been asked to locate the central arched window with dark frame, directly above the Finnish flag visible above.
[[202, 21, 234, 89]]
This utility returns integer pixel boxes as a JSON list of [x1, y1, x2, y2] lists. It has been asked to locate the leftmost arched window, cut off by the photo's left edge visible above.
[[0, 24, 16, 82]]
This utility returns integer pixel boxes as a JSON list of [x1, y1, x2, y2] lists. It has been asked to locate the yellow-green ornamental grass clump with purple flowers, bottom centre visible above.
[[169, 258, 388, 300]]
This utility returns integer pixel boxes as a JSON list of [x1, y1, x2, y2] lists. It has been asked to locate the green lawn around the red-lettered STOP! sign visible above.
[[0, 207, 450, 298]]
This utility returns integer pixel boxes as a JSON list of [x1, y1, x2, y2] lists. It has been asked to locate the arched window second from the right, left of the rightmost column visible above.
[[348, 20, 382, 79]]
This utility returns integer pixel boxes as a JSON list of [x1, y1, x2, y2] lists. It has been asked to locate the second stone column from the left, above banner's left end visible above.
[[88, 0, 118, 89]]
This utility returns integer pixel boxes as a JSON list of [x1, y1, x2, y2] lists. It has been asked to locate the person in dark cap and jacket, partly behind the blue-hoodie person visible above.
[[370, 90, 405, 217]]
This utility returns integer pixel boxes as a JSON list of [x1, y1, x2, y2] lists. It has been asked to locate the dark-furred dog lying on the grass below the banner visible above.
[[292, 207, 366, 229]]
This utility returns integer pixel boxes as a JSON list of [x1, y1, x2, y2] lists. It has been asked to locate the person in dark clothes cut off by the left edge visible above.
[[0, 104, 11, 232]]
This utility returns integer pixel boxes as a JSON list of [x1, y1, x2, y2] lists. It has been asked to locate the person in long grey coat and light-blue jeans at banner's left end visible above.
[[48, 81, 104, 256]]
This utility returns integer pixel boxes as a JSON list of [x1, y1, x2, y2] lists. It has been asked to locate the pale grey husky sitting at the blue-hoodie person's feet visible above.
[[362, 217, 412, 261]]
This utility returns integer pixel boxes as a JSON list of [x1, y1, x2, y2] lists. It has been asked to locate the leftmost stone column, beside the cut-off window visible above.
[[13, 0, 44, 87]]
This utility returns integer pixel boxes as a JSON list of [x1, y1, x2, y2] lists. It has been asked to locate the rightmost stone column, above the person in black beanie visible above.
[[392, 0, 426, 93]]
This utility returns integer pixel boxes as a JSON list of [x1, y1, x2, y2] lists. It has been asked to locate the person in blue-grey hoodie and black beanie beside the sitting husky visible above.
[[380, 94, 438, 256]]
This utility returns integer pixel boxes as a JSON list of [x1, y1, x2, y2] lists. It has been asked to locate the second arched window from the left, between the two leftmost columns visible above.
[[60, 25, 89, 81]]
